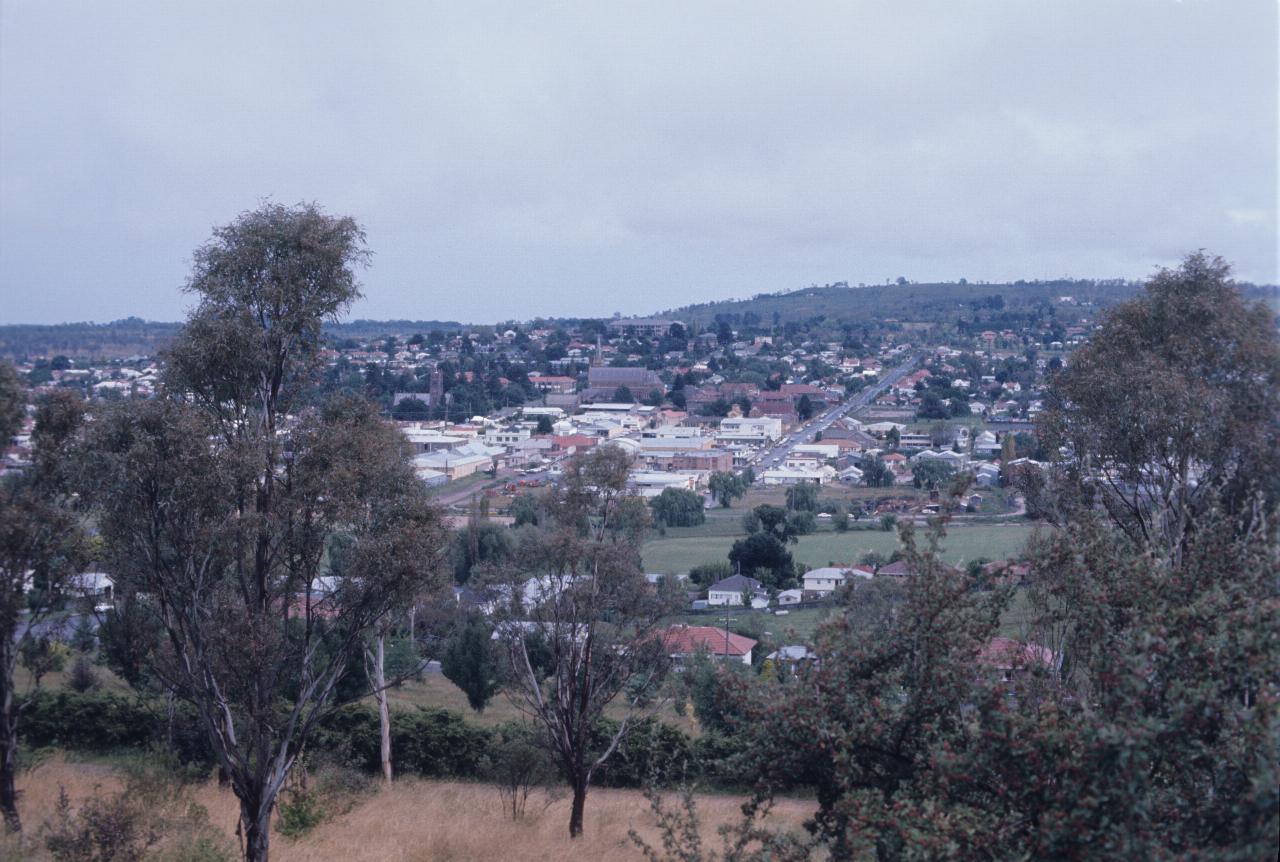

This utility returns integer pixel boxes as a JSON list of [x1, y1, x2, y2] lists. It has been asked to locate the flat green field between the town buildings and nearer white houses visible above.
[[643, 523, 1036, 573]]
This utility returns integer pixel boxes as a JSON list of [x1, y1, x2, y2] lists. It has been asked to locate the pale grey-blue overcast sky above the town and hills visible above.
[[0, 0, 1277, 323]]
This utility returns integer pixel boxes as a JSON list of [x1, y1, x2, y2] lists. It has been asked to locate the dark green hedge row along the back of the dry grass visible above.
[[19, 690, 749, 788]]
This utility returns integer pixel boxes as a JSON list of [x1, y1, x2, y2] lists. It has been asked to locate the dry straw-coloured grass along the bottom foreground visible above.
[[0, 757, 813, 862]]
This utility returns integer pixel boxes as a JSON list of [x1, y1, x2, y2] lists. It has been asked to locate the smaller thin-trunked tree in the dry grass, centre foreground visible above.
[[494, 446, 669, 838]]
